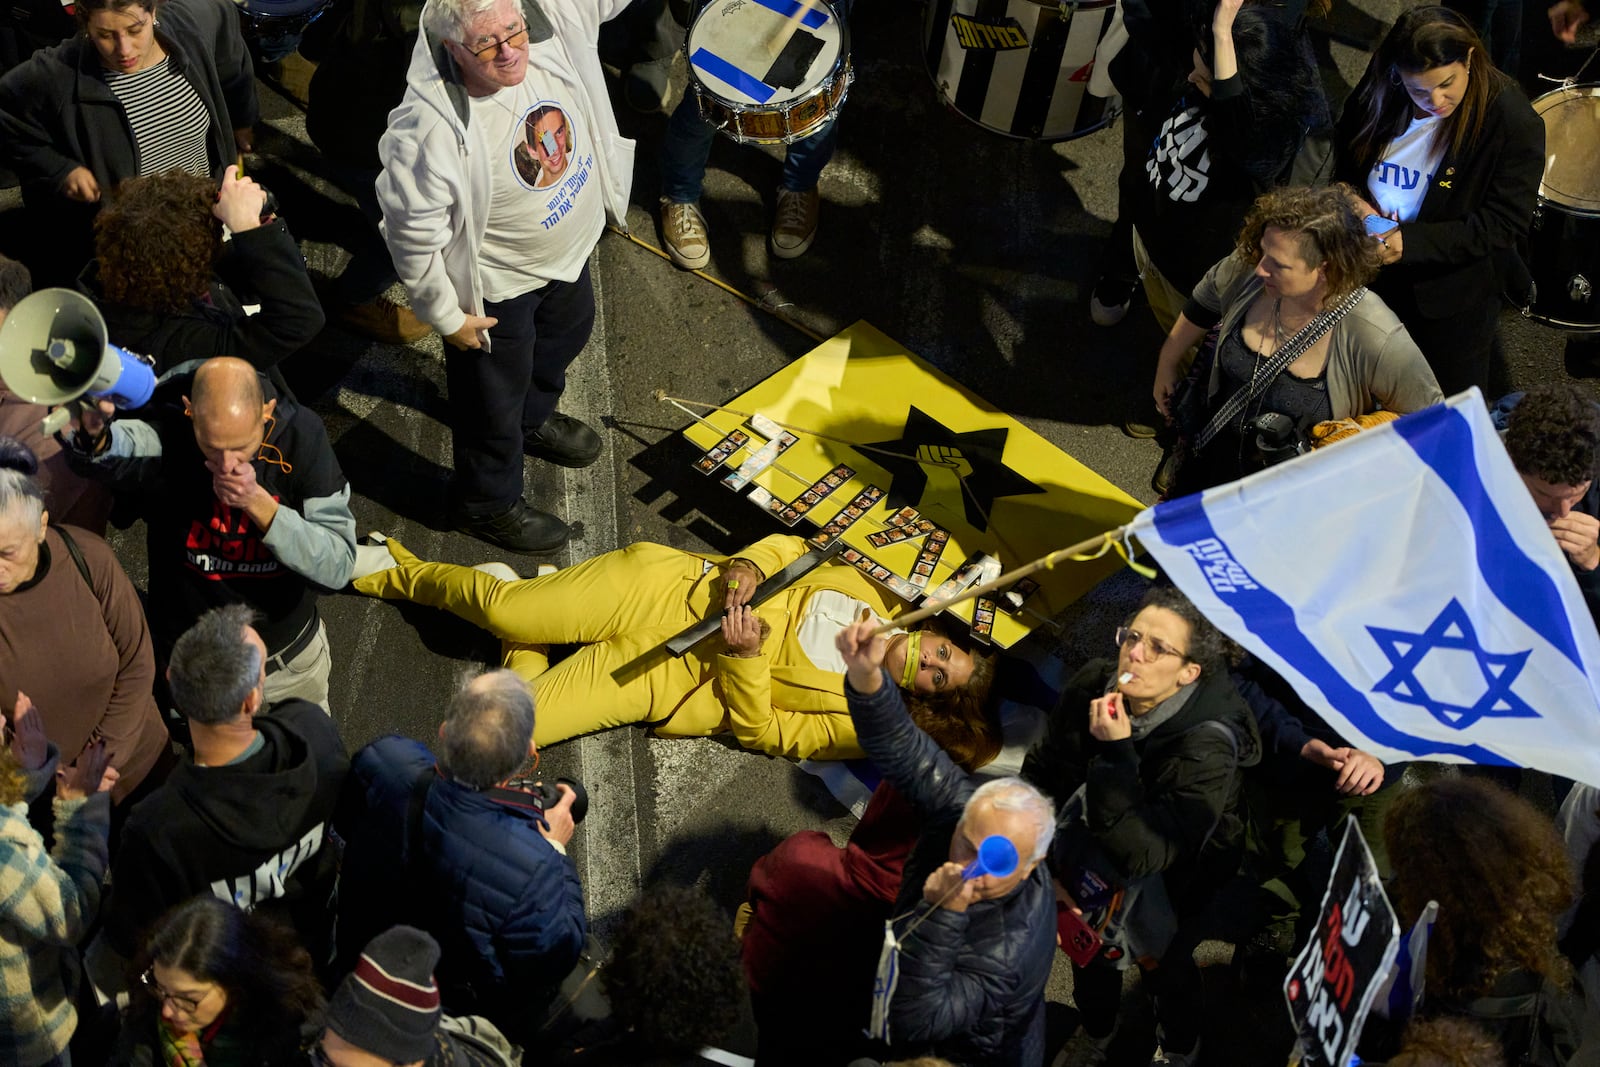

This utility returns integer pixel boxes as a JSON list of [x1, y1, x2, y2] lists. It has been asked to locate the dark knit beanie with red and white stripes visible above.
[[326, 926, 440, 1064]]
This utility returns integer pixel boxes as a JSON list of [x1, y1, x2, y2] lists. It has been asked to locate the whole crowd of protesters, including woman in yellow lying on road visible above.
[[0, 0, 1600, 1067]]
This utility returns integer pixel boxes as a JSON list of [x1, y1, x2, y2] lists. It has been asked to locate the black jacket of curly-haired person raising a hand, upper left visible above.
[[78, 219, 325, 377]]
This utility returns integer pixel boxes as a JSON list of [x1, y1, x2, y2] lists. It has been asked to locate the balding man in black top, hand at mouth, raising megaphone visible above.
[[70, 357, 355, 709]]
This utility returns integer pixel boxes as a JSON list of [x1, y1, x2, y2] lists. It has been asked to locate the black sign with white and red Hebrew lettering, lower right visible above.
[[1283, 819, 1400, 1067]]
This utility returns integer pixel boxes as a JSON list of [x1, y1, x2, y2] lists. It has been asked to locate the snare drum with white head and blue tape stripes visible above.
[[685, 0, 854, 144]]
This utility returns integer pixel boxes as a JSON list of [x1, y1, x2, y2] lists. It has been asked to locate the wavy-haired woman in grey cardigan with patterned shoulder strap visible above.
[[1154, 184, 1443, 496]]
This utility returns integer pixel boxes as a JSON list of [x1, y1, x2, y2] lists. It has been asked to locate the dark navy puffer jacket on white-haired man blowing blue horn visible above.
[[845, 672, 1056, 1067]]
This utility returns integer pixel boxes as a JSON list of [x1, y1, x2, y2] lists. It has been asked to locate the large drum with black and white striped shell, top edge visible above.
[[923, 0, 1117, 141]]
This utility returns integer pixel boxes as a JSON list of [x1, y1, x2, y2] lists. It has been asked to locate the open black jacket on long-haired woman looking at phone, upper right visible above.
[[1334, 85, 1544, 326]]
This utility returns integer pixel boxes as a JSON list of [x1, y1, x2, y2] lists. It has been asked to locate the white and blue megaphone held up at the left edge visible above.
[[0, 290, 155, 435]]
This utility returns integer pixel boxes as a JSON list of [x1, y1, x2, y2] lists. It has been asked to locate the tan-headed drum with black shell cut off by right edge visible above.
[[1523, 85, 1600, 331]]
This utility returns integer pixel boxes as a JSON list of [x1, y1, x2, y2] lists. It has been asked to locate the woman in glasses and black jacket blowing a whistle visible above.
[[1022, 585, 1261, 1065]]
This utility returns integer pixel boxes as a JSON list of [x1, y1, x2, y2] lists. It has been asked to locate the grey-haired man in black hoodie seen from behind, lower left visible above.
[[90, 605, 349, 992]]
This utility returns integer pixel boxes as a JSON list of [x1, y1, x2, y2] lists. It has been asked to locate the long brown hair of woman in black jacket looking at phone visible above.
[[1344, 6, 1510, 174]]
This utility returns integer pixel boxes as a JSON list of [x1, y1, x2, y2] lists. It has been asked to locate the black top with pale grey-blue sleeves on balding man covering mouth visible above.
[[72, 374, 355, 656]]
